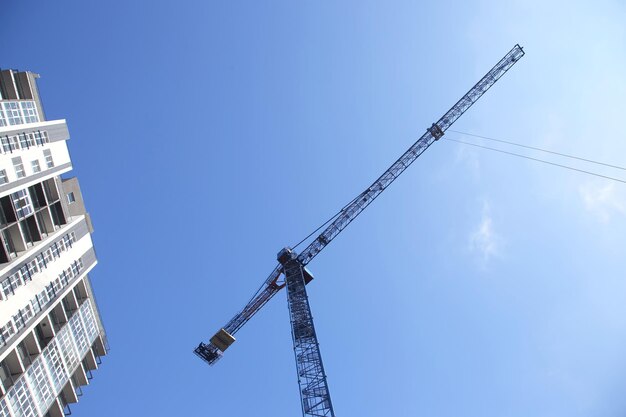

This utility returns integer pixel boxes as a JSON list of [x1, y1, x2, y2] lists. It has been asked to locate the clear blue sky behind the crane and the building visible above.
[[0, 0, 626, 417]]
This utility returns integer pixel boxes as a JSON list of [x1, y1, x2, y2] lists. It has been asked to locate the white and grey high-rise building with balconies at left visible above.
[[0, 70, 108, 417]]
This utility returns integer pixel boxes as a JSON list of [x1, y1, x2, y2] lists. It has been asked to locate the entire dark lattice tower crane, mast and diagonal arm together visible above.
[[194, 45, 524, 417]]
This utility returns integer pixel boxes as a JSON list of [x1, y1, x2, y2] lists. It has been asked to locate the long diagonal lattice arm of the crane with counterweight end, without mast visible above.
[[194, 45, 524, 364]]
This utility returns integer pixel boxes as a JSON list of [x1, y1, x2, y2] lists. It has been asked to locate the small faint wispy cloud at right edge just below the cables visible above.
[[578, 183, 626, 223]]
